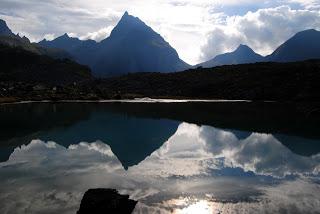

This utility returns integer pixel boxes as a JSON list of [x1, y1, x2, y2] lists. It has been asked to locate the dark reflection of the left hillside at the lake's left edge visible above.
[[0, 103, 91, 161]]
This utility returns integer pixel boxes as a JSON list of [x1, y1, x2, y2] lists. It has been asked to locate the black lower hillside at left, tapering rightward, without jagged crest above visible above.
[[0, 43, 92, 85]]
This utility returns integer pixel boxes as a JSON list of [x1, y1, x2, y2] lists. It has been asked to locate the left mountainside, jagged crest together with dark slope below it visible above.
[[0, 19, 92, 85]]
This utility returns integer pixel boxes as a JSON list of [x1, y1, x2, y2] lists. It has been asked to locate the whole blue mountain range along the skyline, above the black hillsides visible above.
[[0, 12, 320, 77]]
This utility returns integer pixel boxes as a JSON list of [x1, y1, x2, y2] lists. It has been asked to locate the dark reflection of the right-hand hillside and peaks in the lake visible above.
[[102, 102, 320, 156]]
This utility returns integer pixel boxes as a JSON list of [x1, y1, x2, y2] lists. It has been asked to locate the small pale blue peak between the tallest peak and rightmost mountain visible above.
[[196, 45, 264, 68]]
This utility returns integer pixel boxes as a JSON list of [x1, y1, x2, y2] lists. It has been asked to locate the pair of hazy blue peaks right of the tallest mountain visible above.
[[195, 29, 320, 68]]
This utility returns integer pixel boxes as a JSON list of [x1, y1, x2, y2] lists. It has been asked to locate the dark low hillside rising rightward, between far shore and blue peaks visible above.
[[94, 61, 320, 101]]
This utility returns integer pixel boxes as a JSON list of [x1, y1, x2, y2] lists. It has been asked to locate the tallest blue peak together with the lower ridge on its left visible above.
[[39, 12, 189, 77]]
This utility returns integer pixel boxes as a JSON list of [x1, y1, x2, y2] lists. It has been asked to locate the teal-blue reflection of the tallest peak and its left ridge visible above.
[[40, 111, 179, 168]]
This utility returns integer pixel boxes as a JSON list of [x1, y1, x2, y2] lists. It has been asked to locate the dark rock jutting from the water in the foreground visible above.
[[77, 189, 137, 214]]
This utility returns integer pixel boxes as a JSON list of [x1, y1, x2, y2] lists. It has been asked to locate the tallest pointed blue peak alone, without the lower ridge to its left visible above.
[[93, 12, 188, 75]]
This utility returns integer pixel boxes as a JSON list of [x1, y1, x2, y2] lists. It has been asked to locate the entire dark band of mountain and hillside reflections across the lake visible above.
[[0, 103, 320, 164]]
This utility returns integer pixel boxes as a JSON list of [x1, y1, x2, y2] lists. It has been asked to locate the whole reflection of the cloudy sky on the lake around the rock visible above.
[[0, 123, 320, 213]]
